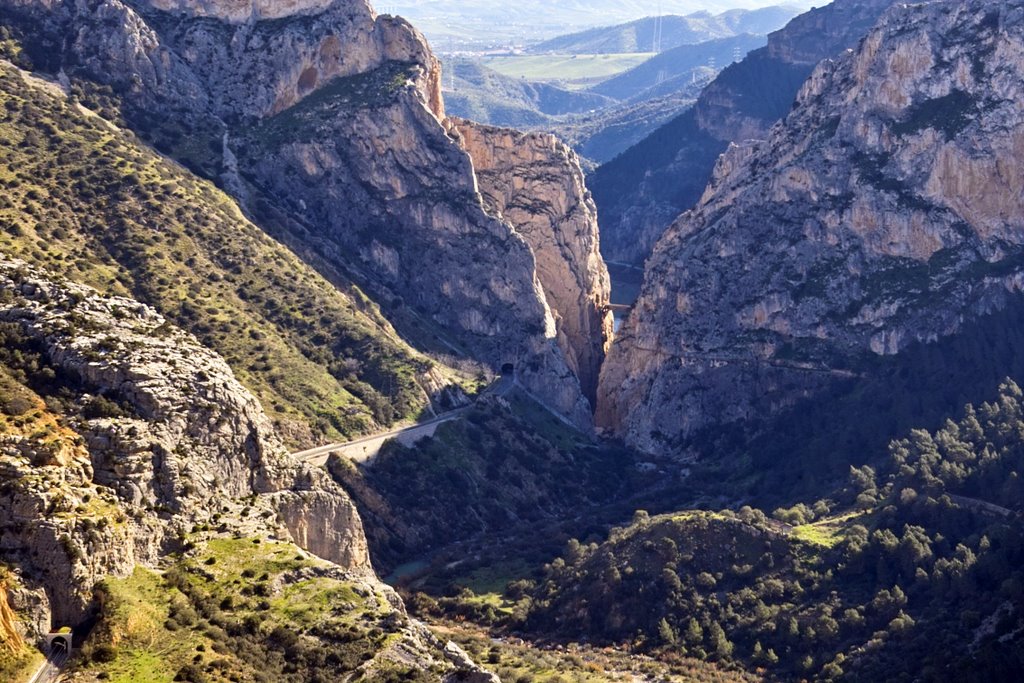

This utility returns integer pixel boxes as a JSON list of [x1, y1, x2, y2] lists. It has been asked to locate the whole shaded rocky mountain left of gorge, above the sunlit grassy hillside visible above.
[[0, 0, 602, 428]]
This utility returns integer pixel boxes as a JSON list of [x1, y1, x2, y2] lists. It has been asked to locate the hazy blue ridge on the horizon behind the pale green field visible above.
[[530, 6, 800, 54]]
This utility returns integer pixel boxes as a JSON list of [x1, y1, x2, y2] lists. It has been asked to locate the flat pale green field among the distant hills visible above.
[[483, 52, 654, 83]]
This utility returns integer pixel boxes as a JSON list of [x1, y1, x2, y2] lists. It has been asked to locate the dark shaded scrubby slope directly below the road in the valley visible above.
[[329, 393, 635, 569]]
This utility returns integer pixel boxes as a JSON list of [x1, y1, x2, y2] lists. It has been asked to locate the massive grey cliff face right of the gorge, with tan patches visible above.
[[599, 1, 1024, 452]]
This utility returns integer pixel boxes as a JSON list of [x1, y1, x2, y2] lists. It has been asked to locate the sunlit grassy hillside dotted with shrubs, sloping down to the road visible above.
[[0, 61, 468, 444]]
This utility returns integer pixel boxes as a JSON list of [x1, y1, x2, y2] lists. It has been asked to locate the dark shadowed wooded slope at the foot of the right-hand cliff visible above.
[[679, 304, 1024, 511]]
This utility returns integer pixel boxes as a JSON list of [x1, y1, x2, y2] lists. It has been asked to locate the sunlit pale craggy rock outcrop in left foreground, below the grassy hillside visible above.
[[0, 260, 372, 624]]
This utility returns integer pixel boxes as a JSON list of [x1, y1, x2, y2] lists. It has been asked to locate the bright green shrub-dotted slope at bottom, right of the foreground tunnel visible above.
[[79, 539, 432, 683]]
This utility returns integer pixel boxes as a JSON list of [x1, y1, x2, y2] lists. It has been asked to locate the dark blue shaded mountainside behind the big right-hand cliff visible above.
[[589, 0, 892, 264]]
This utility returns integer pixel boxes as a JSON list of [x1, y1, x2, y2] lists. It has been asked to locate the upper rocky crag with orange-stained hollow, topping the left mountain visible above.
[[135, 0, 444, 121]]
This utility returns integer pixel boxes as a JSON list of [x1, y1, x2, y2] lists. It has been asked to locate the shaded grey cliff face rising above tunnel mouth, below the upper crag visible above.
[[239, 62, 591, 428]]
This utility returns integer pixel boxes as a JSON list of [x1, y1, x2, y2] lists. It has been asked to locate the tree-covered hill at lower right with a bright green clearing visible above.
[[510, 382, 1024, 681]]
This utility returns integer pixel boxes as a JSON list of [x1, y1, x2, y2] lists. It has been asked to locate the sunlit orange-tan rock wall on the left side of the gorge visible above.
[[453, 119, 612, 402]]
